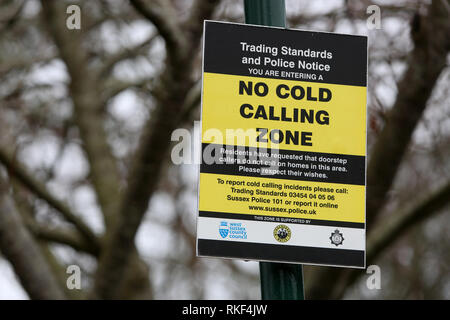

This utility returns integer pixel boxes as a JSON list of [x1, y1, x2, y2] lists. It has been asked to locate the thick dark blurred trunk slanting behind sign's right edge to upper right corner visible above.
[[307, 0, 450, 299]]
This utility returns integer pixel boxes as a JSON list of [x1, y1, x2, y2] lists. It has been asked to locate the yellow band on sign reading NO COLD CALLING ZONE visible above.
[[202, 73, 366, 156]]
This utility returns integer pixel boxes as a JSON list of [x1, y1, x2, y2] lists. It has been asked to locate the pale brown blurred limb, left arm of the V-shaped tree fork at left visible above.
[[41, 0, 120, 226]]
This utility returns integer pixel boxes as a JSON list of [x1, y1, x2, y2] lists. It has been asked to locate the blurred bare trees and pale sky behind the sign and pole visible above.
[[0, 0, 450, 299]]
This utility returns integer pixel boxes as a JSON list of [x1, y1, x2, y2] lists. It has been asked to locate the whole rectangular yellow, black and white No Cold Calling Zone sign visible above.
[[197, 21, 367, 268]]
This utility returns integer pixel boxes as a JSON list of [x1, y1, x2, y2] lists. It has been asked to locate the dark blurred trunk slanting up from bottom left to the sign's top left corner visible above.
[[92, 1, 219, 299]]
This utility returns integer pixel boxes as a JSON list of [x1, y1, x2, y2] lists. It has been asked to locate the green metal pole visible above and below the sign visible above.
[[244, 0, 305, 300]]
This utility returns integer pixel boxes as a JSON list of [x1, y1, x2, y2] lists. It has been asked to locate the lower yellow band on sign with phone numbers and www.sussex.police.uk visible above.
[[199, 173, 365, 223]]
